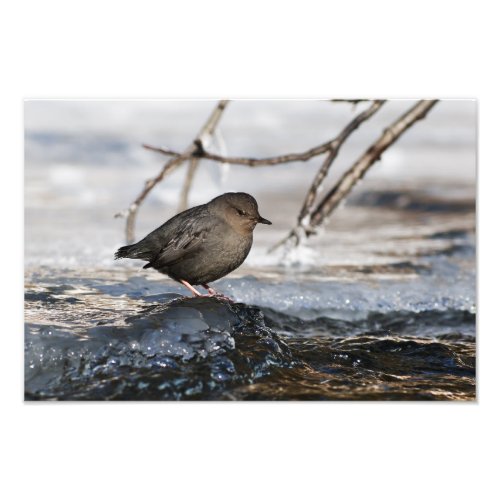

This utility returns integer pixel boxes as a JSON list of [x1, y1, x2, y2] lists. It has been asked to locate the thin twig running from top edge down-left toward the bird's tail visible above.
[[119, 100, 229, 243]]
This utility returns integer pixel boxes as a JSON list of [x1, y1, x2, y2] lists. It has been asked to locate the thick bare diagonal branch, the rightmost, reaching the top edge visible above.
[[310, 99, 438, 228]]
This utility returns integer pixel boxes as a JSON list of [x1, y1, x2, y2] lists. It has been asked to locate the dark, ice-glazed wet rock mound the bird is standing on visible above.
[[26, 298, 291, 399]]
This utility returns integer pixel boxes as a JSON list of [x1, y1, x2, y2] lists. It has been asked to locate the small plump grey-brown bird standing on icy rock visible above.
[[115, 193, 271, 296]]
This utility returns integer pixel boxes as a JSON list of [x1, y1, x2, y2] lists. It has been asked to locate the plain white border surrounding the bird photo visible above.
[[0, 0, 500, 500]]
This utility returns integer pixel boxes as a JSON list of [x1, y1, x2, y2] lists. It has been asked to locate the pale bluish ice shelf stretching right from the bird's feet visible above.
[[220, 257, 476, 319]]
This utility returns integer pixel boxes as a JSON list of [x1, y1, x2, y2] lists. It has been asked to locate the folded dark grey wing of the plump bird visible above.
[[147, 214, 214, 267]]
